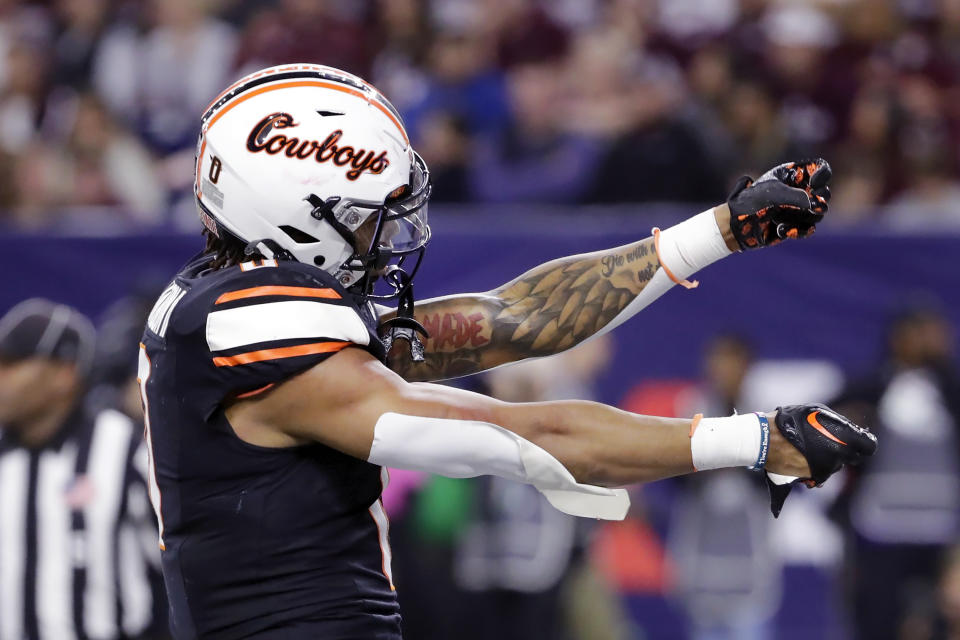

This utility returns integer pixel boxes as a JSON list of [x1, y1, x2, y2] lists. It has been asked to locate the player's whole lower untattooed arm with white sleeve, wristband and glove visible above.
[[227, 342, 872, 517]]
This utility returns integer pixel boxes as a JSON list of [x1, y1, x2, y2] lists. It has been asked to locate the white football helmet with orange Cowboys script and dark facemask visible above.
[[194, 64, 431, 297]]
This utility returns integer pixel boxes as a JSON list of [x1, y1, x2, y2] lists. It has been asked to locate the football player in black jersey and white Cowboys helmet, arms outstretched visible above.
[[139, 64, 875, 639]]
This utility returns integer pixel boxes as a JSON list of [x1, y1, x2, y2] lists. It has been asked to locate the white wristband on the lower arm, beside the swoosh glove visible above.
[[690, 413, 769, 471]]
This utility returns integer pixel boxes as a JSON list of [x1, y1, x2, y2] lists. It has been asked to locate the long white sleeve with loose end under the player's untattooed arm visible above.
[[367, 413, 630, 520]]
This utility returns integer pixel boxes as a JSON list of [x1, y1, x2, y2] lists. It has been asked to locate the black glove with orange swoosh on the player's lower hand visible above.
[[766, 404, 877, 517]]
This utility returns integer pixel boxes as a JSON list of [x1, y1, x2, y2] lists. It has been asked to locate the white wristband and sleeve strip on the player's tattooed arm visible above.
[[595, 209, 732, 336]]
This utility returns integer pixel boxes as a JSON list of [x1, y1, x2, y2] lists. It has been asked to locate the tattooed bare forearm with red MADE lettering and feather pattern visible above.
[[388, 238, 660, 380]]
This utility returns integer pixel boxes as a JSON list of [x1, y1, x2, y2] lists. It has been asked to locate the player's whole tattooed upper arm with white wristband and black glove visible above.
[[384, 160, 830, 380]]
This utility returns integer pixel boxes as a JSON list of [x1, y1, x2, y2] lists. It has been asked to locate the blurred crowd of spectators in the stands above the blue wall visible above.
[[0, 0, 960, 230]]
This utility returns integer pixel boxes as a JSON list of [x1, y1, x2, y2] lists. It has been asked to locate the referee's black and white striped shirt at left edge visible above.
[[0, 410, 159, 640]]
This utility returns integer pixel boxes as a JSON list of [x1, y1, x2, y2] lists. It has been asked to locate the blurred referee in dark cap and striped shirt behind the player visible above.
[[0, 299, 159, 640]]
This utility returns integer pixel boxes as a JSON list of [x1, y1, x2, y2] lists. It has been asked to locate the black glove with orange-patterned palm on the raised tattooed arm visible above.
[[727, 158, 832, 251]]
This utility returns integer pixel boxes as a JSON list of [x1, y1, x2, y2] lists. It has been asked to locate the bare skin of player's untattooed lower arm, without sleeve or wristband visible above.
[[227, 349, 809, 486]]
